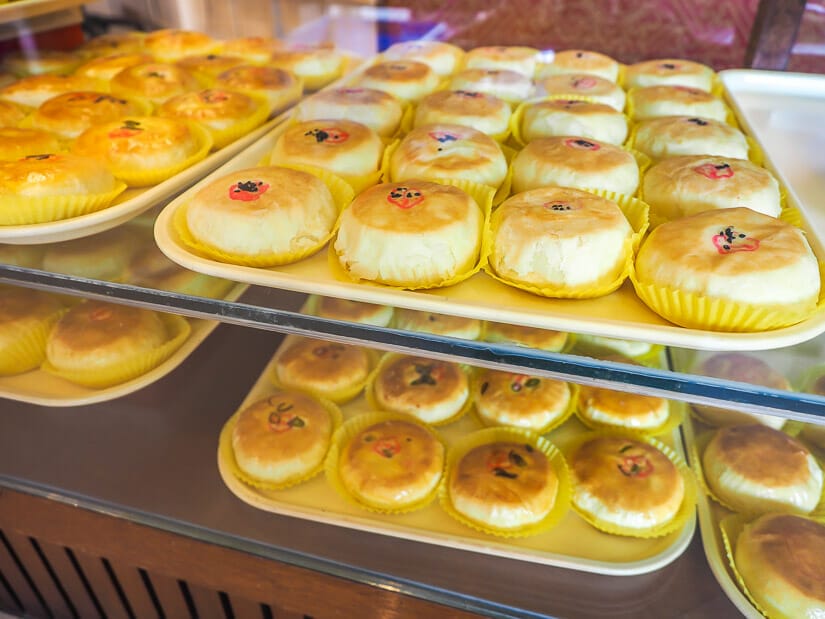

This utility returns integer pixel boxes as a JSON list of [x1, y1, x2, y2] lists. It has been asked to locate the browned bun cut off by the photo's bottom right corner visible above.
[[734, 514, 825, 618]]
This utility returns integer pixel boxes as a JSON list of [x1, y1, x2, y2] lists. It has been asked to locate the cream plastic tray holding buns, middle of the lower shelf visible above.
[[218, 337, 696, 576]]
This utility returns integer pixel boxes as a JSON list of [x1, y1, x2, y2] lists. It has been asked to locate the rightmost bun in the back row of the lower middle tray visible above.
[[578, 385, 670, 430]]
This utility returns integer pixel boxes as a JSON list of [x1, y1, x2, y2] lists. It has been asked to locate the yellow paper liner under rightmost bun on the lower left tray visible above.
[[40, 314, 191, 389]]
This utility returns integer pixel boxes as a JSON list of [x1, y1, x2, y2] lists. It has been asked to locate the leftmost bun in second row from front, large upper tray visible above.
[[269, 119, 384, 176]]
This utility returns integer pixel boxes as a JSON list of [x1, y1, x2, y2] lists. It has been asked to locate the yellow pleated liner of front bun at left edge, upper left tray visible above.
[[0, 181, 126, 226]]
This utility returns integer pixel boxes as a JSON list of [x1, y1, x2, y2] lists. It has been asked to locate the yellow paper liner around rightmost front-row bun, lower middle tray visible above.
[[565, 430, 697, 539]]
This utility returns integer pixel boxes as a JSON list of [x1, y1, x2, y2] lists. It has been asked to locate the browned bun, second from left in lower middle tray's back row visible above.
[[372, 355, 470, 423]]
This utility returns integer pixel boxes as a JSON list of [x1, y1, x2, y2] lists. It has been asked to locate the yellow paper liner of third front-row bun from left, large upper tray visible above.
[[482, 189, 649, 299]]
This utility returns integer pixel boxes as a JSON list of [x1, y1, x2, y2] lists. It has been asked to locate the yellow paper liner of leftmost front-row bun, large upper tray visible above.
[[172, 164, 353, 268]]
